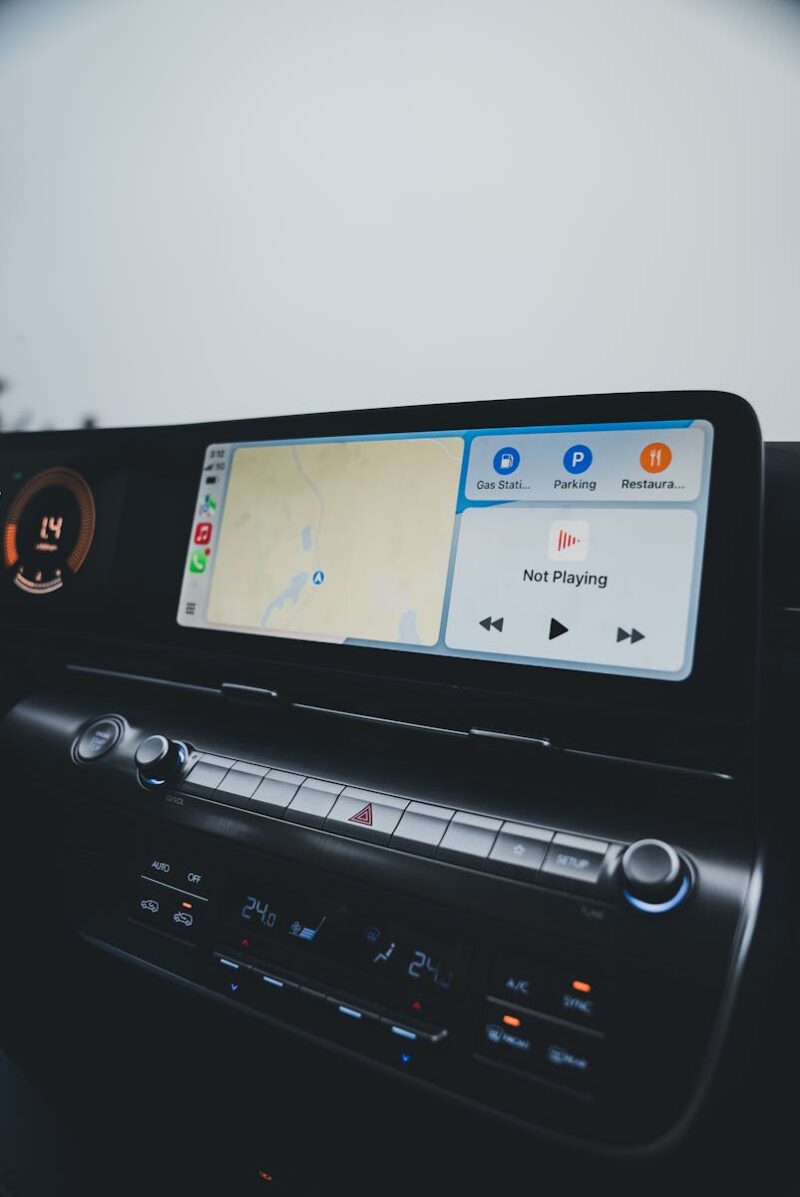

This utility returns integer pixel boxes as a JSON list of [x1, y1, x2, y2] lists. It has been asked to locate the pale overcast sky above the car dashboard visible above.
[[0, 0, 800, 439]]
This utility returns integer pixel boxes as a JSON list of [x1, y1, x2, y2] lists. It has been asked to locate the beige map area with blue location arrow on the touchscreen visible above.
[[207, 437, 463, 644]]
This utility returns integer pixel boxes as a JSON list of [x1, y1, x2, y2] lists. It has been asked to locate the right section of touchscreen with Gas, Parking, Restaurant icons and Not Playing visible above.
[[444, 424, 710, 679]]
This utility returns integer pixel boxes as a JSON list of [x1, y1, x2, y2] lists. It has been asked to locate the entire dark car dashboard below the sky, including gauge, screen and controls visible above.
[[0, 391, 800, 1195]]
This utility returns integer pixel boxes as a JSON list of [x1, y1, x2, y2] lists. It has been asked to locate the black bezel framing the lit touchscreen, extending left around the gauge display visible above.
[[0, 391, 763, 719]]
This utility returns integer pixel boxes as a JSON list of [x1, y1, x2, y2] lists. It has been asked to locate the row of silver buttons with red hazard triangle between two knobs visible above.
[[181, 753, 610, 888]]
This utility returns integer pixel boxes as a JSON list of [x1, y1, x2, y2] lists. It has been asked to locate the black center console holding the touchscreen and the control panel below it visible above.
[[0, 393, 760, 1154]]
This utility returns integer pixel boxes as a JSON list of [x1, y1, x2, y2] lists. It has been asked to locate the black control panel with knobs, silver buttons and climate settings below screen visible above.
[[6, 695, 746, 1150]]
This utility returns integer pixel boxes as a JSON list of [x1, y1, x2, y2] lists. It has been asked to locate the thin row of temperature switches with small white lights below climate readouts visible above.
[[214, 952, 447, 1047]]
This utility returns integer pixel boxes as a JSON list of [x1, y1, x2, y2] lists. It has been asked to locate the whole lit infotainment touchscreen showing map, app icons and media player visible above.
[[177, 420, 713, 681]]
